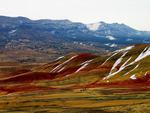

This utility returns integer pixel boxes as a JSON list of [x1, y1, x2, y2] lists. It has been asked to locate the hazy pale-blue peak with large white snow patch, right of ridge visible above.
[[87, 22, 142, 36]]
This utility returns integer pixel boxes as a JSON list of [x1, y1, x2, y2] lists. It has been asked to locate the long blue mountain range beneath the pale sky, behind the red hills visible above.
[[0, 16, 150, 61]]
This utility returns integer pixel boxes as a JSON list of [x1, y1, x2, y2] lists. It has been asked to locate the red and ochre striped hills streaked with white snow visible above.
[[0, 44, 150, 92]]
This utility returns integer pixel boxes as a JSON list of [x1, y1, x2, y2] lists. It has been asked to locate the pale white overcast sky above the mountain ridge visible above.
[[0, 0, 150, 31]]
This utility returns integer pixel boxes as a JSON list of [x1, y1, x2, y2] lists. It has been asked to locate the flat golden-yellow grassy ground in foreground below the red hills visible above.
[[0, 88, 150, 113]]
